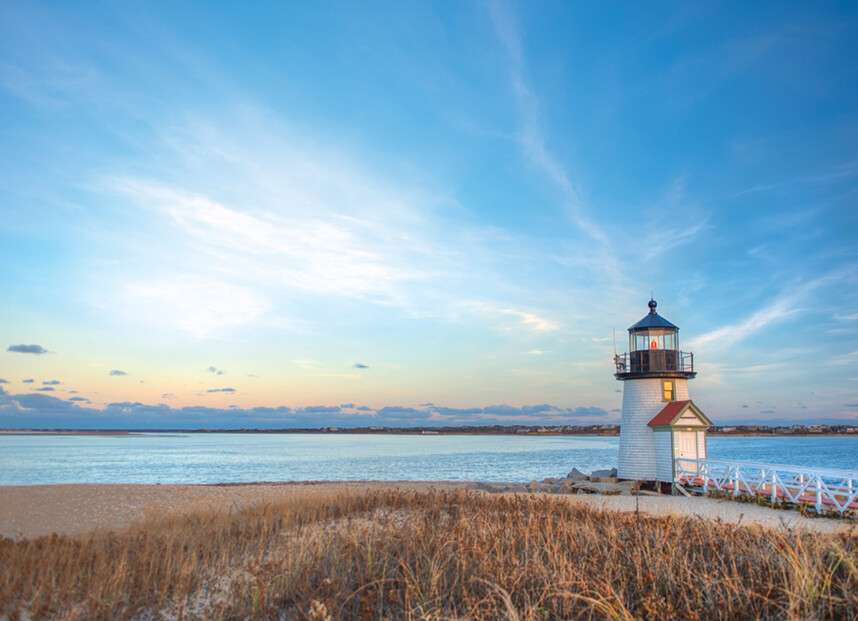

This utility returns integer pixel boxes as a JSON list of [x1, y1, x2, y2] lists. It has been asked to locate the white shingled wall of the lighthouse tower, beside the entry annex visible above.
[[617, 378, 688, 481]]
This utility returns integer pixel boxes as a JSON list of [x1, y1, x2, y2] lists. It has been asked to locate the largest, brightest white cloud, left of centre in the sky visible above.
[[111, 141, 450, 337]]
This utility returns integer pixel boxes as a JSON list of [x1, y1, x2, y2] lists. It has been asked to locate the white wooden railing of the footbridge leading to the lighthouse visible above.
[[675, 458, 858, 513]]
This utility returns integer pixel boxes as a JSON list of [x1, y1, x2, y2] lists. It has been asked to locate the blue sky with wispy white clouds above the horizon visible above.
[[0, 0, 858, 429]]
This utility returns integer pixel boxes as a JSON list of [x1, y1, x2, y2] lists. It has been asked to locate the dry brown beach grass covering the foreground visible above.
[[0, 491, 858, 621]]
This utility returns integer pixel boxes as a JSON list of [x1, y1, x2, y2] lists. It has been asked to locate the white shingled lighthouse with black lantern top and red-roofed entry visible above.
[[614, 299, 712, 483]]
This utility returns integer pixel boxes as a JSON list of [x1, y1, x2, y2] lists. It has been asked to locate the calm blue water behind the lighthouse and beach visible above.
[[0, 434, 858, 485]]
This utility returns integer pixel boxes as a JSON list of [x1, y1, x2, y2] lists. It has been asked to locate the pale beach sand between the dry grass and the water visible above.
[[0, 481, 858, 539]]
